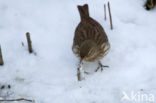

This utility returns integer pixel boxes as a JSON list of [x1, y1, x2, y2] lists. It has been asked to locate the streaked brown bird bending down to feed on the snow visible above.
[[72, 4, 110, 75]]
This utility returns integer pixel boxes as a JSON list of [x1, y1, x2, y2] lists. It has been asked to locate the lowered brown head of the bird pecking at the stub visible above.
[[80, 40, 98, 61]]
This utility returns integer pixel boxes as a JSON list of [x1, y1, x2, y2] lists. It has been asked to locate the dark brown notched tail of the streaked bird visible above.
[[77, 4, 89, 20]]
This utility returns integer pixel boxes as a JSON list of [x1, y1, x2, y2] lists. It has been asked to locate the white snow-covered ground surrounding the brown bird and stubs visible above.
[[0, 0, 156, 103]]
